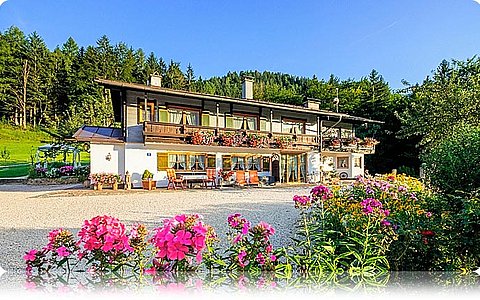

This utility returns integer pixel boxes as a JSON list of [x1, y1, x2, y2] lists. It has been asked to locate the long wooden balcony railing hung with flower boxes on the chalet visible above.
[[143, 122, 375, 153]]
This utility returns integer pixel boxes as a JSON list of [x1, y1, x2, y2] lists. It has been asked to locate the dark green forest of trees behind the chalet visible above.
[[0, 27, 480, 175]]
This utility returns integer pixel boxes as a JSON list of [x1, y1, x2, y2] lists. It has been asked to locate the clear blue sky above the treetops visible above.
[[0, 0, 480, 88]]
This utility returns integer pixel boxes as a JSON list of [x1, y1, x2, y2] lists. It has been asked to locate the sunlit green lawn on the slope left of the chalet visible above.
[[0, 124, 90, 178]]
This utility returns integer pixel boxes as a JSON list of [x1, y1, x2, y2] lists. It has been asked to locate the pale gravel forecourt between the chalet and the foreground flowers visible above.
[[0, 185, 310, 274]]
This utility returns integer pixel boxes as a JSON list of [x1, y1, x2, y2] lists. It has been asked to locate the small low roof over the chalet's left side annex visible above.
[[73, 125, 123, 143]]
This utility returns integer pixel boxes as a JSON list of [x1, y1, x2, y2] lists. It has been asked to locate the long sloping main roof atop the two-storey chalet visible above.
[[95, 79, 384, 124]]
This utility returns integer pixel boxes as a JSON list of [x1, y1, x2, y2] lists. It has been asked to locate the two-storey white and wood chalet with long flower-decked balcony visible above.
[[74, 77, 381, 187]]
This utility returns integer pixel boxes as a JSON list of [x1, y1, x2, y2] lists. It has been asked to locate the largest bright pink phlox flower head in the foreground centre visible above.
[[152, 214, 208, 263]]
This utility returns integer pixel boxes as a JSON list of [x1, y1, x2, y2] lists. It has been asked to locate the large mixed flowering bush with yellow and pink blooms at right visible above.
[[284, 174, 478, 273]]
